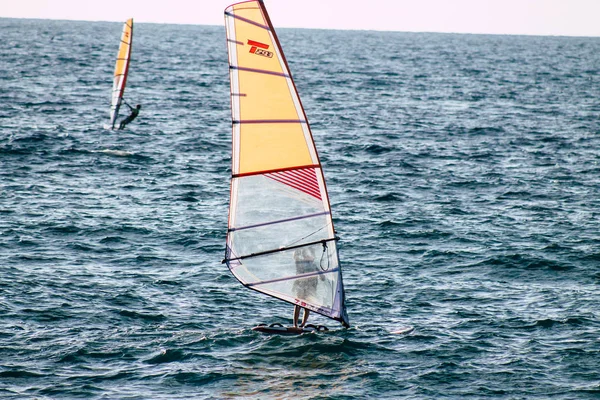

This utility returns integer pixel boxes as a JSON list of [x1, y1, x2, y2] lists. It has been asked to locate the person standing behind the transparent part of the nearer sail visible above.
[[292, 247, 325, 328]]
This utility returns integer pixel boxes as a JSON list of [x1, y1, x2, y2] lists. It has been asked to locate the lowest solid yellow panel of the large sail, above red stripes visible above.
[[240, 123, 312, 174]]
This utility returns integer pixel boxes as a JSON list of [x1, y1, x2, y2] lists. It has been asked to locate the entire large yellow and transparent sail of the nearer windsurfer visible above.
[[223, 1, 349, 327]]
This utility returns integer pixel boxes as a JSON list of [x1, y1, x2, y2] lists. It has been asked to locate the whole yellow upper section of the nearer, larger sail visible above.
[[226, 1, 318, 174]]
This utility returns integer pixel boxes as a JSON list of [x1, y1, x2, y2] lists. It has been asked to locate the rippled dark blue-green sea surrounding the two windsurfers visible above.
[[0, 19, 600, 400]]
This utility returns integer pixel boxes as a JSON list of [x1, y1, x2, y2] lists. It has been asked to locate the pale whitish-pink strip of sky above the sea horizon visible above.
[[0, 0, 600, 37]]
